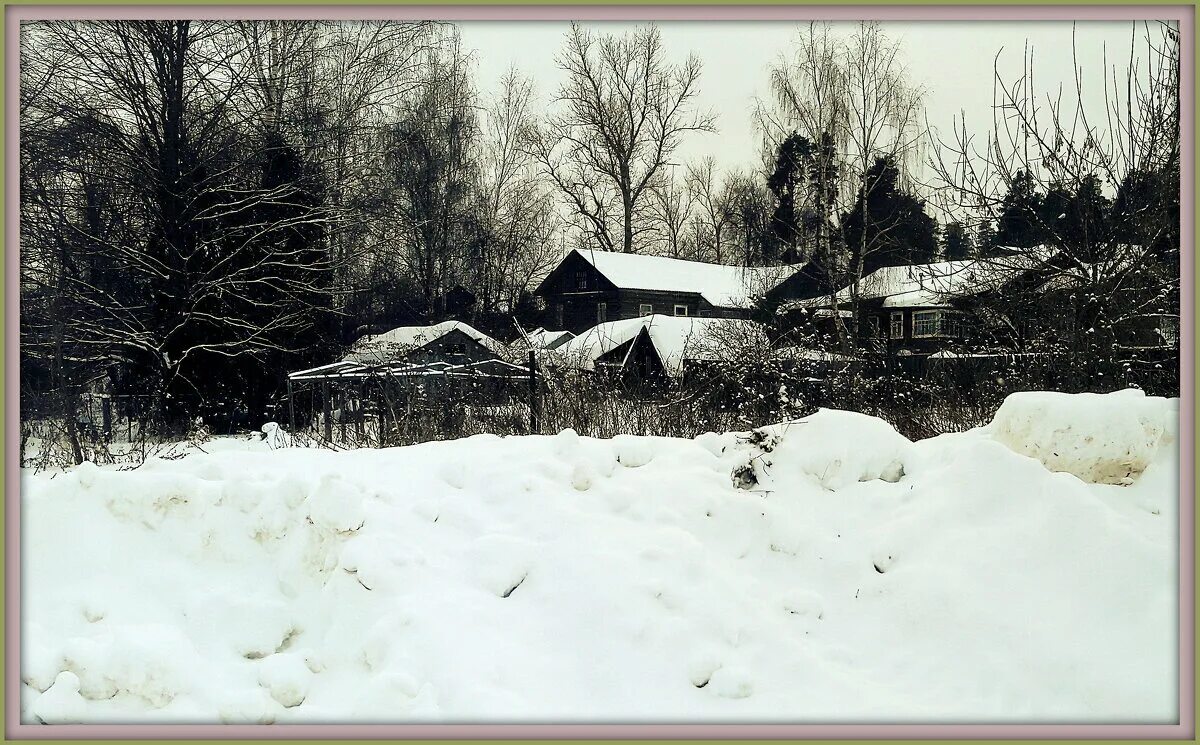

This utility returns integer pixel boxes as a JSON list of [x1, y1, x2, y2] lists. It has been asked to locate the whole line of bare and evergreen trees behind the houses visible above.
[[19, 20, 1180, 441]]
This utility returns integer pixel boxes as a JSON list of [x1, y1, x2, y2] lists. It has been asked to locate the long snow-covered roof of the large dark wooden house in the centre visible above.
[[575, 250, 799, 308]]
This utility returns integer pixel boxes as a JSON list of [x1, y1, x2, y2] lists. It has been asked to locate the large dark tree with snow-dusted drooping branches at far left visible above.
[[22, 20, 343, 427]]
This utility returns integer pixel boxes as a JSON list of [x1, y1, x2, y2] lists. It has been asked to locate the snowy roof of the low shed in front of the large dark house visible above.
[[556, 313, 766, 377]]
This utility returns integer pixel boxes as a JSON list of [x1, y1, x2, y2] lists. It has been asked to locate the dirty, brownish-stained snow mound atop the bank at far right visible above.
[[989, 389, 1178, 485]]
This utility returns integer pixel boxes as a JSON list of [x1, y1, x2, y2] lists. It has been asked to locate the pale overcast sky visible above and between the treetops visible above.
[[460, 20, 1161, 197]]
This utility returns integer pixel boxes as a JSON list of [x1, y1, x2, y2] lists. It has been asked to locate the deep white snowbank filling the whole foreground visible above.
[[20, 391, 1178, 723]]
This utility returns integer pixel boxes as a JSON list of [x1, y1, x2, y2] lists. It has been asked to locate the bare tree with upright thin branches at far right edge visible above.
[[931, 23, 1180, 375]]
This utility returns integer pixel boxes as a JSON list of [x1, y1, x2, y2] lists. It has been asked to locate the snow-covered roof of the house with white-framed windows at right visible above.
[[787, 247, 1051, 308]]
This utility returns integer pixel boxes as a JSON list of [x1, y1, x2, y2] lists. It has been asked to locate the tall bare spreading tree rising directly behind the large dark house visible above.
[[529, 24, 715, 253]]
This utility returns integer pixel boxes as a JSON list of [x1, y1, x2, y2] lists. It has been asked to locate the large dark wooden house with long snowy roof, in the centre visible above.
[[535, 250, 800, 334]]
